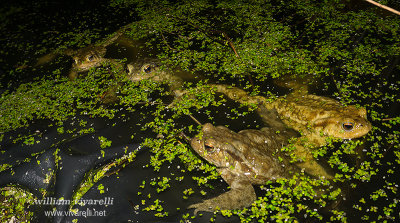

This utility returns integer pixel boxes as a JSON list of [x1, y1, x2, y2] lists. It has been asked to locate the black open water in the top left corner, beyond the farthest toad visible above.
[[0, 0, 138, 88]]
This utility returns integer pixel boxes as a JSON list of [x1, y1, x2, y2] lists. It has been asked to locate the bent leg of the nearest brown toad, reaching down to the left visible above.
[[188, 170, 257, 215]]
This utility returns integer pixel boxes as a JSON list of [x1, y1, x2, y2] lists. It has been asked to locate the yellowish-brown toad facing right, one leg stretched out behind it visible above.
[[212, 85, 371, 178]]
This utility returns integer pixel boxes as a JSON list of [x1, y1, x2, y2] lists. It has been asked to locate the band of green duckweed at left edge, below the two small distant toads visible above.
[[0, 61, 149, 132]]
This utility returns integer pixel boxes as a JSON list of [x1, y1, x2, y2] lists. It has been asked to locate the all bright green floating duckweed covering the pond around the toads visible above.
[[0, 0, 400, 222]]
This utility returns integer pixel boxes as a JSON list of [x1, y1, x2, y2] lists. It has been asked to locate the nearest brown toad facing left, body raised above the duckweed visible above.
[[188, 119, 300, 214]]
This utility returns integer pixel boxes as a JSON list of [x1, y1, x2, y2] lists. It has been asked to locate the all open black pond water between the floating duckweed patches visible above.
[[0, 1, 400, 222]]
